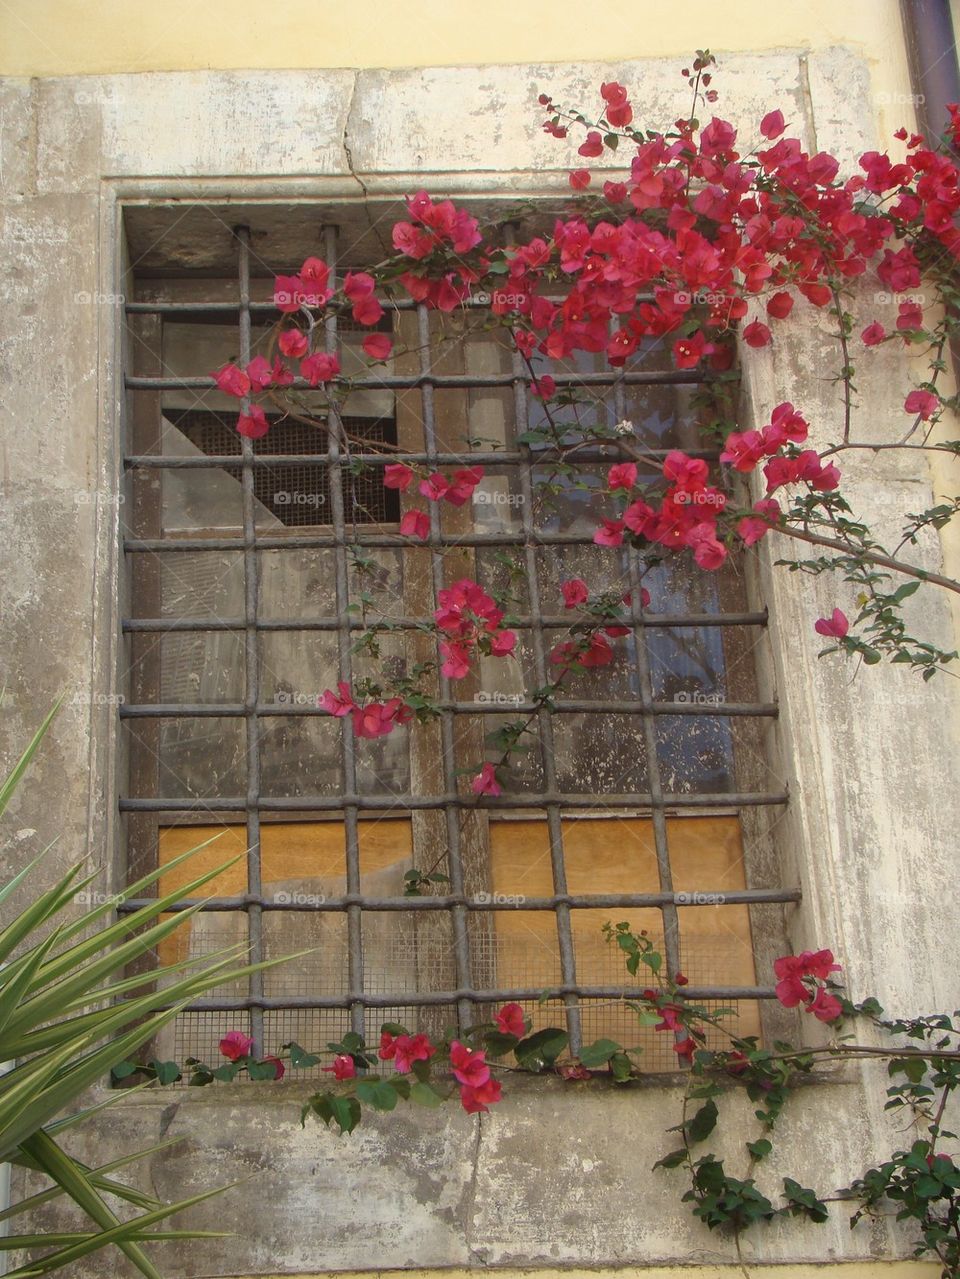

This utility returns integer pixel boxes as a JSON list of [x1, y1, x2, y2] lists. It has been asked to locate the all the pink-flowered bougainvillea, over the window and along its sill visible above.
[[118, 51, 960, 1274]]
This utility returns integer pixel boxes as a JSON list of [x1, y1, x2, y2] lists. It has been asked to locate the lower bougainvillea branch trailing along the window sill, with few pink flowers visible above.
[[122, 923, 960, 1275]]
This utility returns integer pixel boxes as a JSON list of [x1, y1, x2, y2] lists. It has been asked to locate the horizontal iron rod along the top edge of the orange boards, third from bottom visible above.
[[120, 790, 787, 815]]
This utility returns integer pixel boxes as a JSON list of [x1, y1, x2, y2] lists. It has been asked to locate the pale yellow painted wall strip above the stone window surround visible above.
[[0, 0, 902, 84]]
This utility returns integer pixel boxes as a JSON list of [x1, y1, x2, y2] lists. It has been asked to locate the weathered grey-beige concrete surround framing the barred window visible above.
[[0, 50, 960, 1275]]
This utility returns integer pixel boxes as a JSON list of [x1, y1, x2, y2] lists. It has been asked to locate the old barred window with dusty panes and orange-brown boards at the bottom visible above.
[[120, 201, 798, 1069]]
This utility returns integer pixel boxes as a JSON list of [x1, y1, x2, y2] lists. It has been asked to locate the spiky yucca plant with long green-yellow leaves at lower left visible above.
[[0, 707, 299, 1279]]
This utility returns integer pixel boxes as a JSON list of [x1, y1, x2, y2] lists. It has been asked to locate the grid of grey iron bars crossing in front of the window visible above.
[[119, 214, 799, 1053]]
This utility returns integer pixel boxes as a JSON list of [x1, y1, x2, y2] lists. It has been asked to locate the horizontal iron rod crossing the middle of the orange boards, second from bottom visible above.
[[116, 888, 800, 914]]
